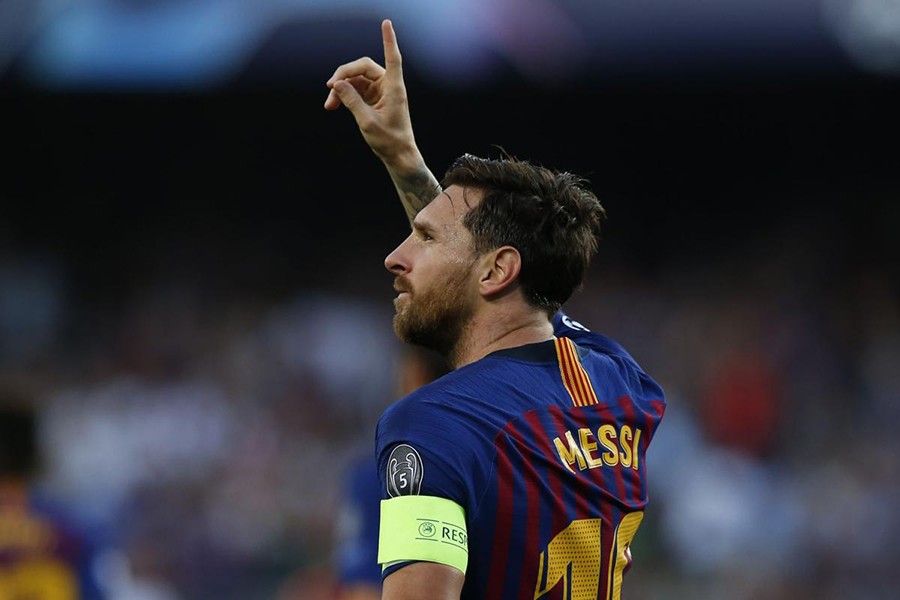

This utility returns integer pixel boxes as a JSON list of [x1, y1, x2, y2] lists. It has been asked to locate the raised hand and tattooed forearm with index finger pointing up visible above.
[[325, 20, 441, 223]]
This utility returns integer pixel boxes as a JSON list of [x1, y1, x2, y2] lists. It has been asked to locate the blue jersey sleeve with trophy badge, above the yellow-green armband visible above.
[[376, 388, 490, 577]]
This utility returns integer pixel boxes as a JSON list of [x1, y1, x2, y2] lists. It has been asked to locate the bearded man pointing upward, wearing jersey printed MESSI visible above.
[[325, 21, 665, 600]]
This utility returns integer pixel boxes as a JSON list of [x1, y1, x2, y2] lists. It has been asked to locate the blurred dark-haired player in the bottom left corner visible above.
[[0, 390, 103, 600]]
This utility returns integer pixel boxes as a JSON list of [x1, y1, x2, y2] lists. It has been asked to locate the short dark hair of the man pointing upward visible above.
[[442, 154, 606, 316]]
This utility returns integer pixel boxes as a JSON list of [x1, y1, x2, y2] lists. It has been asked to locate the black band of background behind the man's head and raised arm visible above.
[[0, 71, 900, 296]]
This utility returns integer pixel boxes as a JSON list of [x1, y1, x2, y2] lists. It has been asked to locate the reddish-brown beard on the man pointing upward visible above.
[[394, 265, 475, 362]]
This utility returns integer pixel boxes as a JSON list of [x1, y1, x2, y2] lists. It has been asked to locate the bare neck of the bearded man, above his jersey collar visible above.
[[448, 306, 553, 369]]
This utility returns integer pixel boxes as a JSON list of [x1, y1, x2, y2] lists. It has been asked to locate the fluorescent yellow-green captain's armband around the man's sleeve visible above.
[[378, 496, 469, 573]]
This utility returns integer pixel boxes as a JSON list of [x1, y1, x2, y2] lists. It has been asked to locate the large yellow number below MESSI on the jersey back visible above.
[[534, 512, 644, 600]]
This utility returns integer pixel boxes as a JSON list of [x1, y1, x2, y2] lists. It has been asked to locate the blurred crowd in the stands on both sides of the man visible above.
[[0, 203, 900, 600]]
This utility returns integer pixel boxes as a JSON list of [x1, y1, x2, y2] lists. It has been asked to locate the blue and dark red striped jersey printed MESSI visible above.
[[376, 313, 665, 600]]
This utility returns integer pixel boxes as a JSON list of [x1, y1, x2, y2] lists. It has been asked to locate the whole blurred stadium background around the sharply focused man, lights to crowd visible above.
[[0, 0, 900, 600]]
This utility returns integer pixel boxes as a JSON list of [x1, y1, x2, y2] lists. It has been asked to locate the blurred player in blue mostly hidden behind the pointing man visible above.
[[335, 346, 449, 600]]
